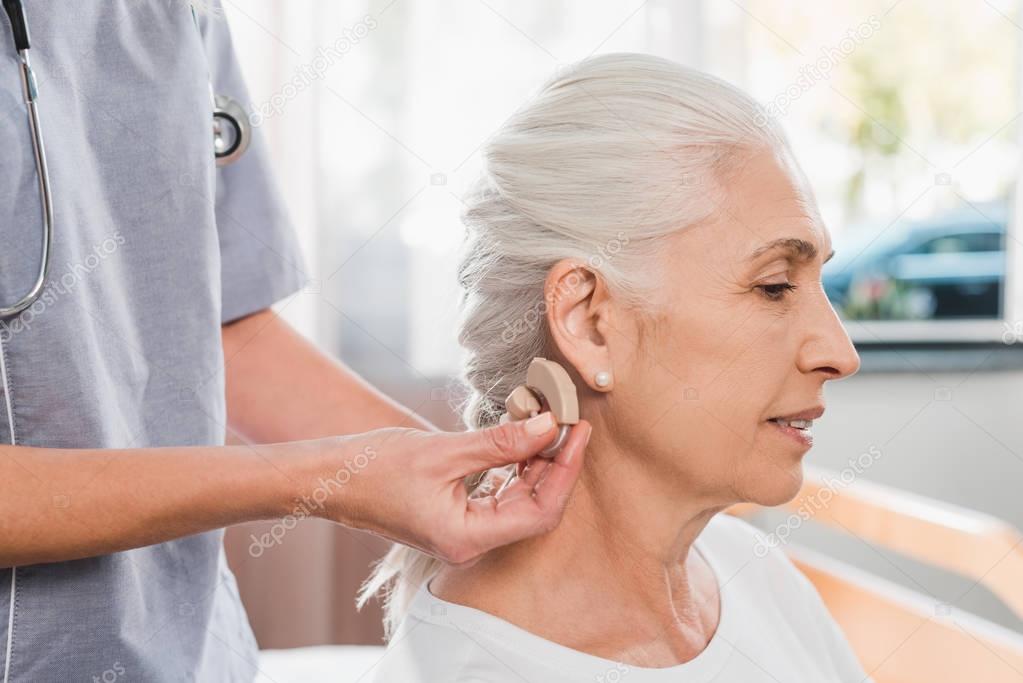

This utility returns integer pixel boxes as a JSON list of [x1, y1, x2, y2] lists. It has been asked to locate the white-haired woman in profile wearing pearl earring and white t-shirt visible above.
[[360, 54, 866, 683]]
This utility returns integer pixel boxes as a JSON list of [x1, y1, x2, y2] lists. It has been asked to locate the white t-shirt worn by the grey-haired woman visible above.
[[373, 514, 866, 683]]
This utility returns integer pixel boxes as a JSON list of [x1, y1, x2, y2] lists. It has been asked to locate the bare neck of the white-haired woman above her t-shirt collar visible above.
[[431, 446, 723, 667]]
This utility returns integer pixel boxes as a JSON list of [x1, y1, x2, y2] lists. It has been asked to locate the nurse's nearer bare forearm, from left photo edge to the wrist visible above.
[[0, 437, 306, 566]]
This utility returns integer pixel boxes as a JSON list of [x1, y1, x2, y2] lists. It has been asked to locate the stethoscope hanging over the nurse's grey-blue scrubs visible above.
[[0, 0, 252, 318]]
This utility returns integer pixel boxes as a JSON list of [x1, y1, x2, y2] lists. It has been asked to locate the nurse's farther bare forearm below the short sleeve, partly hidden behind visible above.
[[223, 311, 437, 443]]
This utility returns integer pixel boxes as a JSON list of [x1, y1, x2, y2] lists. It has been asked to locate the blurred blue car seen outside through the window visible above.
[[822, 202, 1008, 320]]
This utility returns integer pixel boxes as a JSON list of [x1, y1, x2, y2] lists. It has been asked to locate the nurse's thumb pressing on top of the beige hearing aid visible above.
[[442, 412, 558, 477]]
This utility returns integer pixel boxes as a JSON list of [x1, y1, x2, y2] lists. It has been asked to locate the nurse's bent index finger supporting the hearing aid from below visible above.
[[464, 420, 591, 553]]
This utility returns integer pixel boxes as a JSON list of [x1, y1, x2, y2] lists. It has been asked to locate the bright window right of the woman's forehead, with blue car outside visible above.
[[707, 0, 1020, 343]]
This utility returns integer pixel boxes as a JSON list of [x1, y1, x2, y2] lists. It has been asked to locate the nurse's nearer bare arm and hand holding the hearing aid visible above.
[[0, 404, 589, 567]]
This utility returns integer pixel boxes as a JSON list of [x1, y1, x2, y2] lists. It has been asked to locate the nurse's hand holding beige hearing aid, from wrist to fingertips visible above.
[[299, 412, 591, 565]]
